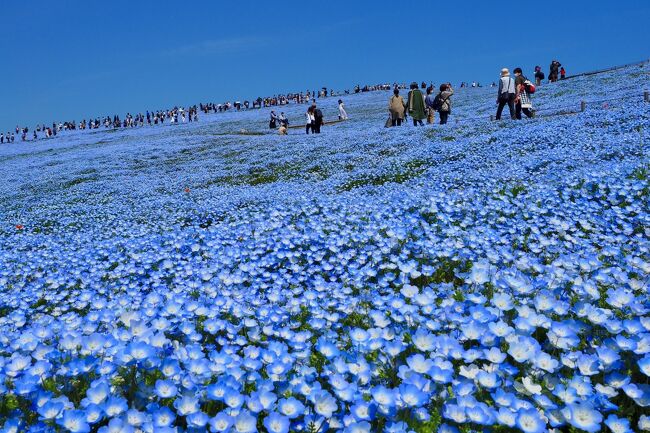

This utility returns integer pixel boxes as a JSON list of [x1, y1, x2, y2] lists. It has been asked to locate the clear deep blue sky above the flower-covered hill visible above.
[[0, 0, 650, 131]]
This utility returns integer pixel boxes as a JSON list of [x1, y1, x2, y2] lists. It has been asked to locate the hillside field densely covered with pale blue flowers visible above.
[[0, 64, 650, 433]]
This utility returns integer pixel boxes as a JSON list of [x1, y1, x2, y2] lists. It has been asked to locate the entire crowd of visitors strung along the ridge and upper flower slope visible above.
[[0, 60, 566, 140]]
